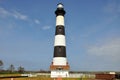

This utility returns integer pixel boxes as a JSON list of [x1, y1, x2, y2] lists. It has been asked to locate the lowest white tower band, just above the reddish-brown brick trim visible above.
[[53, 57, 67, 65]]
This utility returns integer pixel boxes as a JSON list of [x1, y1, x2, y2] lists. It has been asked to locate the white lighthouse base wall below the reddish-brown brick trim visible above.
[[51, 70, 69, 78]]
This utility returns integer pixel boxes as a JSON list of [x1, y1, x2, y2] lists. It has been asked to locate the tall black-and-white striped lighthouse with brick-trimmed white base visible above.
[[50, 3, 70, 77]]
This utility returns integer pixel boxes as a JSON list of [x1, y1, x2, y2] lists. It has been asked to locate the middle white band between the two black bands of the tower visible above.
[[54, 35, 66, 46]]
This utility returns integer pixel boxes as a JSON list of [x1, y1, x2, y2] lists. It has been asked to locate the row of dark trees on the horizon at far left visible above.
[[0, 60, 25, 73]]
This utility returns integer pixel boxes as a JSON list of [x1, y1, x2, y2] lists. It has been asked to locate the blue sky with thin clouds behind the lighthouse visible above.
[[0, 0, 120, 71]]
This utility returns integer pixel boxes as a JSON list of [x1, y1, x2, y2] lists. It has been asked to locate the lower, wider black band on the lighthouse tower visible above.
[[54, 46, 66, 57]]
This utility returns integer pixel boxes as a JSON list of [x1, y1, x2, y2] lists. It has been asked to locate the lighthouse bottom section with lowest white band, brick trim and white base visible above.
[[50, 57, 70, 78]]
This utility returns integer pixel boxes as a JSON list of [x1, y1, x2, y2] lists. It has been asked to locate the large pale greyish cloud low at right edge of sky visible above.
[[88, 38, 120, 62]]
